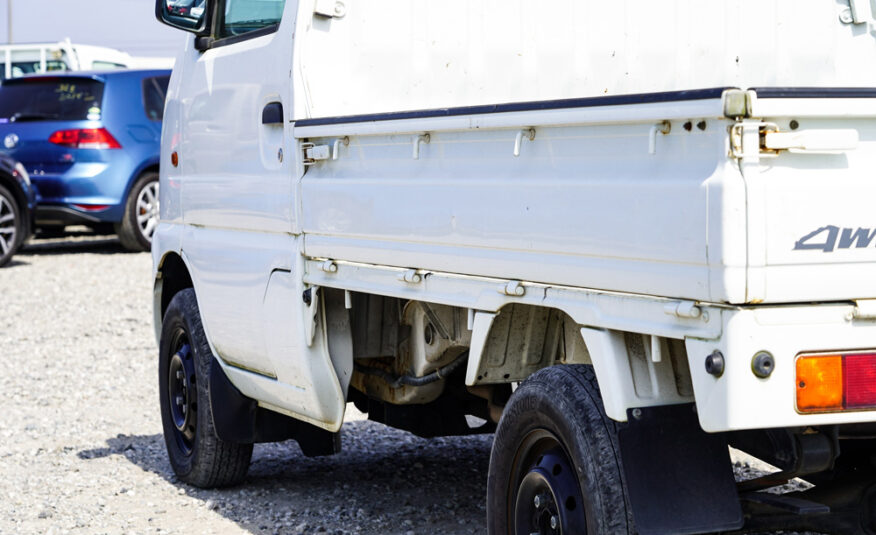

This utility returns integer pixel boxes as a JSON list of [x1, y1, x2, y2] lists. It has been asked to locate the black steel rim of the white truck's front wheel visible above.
[[167, 344, 198, 453]]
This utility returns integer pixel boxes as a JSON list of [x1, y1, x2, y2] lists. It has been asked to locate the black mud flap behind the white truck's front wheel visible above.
[[210, 357, 341, 457]]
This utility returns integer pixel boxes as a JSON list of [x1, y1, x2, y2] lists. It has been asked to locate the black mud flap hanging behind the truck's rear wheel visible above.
[[618, 404, 743, 535]]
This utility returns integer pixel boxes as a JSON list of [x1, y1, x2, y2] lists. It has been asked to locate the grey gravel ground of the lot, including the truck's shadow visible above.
[[0, 236, 820, 535]]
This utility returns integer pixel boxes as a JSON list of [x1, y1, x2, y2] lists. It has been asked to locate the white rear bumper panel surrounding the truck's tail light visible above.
[[685, 303, 876, 432]]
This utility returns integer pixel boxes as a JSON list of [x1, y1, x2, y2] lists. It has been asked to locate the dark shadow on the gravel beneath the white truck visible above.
[[78, 421, 492, 535]]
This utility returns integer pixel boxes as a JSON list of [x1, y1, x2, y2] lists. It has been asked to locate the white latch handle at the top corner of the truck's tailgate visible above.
[[730, 120, 860, 159]]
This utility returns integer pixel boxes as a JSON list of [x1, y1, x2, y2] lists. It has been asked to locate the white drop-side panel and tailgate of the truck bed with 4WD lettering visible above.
[[295, 88, 876, 303]]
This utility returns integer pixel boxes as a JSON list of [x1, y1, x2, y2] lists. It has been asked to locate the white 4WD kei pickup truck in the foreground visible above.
[[152, 0, 876, 535]]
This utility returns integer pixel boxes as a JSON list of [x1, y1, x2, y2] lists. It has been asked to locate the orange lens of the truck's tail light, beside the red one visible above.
[[797, 355, 843, 412]]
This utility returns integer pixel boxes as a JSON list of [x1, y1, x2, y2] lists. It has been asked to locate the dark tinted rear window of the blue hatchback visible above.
[[0, 77, 104, 123]]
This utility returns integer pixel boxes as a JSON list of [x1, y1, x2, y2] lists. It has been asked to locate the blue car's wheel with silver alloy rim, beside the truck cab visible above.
[[115, 172, 158, 251]]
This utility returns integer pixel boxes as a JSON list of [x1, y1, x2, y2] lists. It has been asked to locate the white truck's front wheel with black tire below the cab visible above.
[[158, 288, 252, 488]]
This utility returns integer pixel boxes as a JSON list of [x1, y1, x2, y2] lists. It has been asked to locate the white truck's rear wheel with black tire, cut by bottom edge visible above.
[[487, 365, 634, 535]]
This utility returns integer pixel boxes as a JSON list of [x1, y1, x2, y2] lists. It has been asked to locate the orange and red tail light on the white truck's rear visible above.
[[797, 352, 876, 413]]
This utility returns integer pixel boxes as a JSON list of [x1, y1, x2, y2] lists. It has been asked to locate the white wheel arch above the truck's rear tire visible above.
[[466, 304, 694, 422]]
